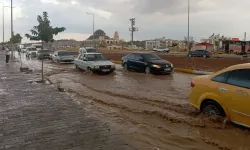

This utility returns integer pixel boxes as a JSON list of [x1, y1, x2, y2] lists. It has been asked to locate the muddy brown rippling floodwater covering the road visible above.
[[20, 54, 250, 150]]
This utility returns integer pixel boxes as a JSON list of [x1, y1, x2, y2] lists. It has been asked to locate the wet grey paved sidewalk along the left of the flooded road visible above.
[[0, 51, 135, 150]]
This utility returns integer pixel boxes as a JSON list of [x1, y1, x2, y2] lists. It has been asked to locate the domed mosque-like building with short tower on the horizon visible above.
[[83, 29, 120, 49]]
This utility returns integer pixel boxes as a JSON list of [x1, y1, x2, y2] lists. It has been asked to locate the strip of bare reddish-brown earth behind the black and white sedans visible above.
[[57, 49, 250, 72]]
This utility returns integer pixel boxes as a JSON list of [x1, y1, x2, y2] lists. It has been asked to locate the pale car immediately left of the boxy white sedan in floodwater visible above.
[[52, 50, 75, 63]]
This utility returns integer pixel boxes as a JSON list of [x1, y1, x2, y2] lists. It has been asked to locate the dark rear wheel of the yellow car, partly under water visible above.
[[201, 101, 225, 117]]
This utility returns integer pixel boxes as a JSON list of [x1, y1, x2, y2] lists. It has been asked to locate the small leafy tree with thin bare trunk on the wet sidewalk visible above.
[[25, 12, 66, 82]]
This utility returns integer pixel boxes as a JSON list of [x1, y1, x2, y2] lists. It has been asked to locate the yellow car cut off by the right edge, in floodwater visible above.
[[189, 63, 250, 128]]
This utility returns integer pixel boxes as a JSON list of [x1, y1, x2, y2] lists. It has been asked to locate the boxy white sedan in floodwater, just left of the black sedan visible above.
[[74, 53, 115, 73]]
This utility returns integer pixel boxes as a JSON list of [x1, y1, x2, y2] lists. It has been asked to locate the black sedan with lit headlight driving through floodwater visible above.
[[122, 53, 174, 74]]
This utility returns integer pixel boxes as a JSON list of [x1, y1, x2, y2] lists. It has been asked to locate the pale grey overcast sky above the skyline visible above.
[[0, 0, 250, 41]]
